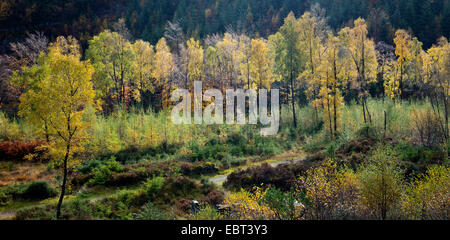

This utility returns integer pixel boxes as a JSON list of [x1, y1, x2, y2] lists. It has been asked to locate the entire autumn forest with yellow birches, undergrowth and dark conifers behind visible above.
[[0, 0, 450, 220]]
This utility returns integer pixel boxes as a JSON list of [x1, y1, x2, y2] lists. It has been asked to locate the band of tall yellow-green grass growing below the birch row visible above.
[[0, 99, 442, 162]]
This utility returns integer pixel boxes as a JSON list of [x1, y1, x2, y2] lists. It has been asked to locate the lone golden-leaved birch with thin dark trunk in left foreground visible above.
[[20, 37, 95, 218]]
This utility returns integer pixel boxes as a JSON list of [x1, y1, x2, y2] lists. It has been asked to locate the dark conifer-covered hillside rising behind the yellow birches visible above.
[[0, 0, 450, 52]]
